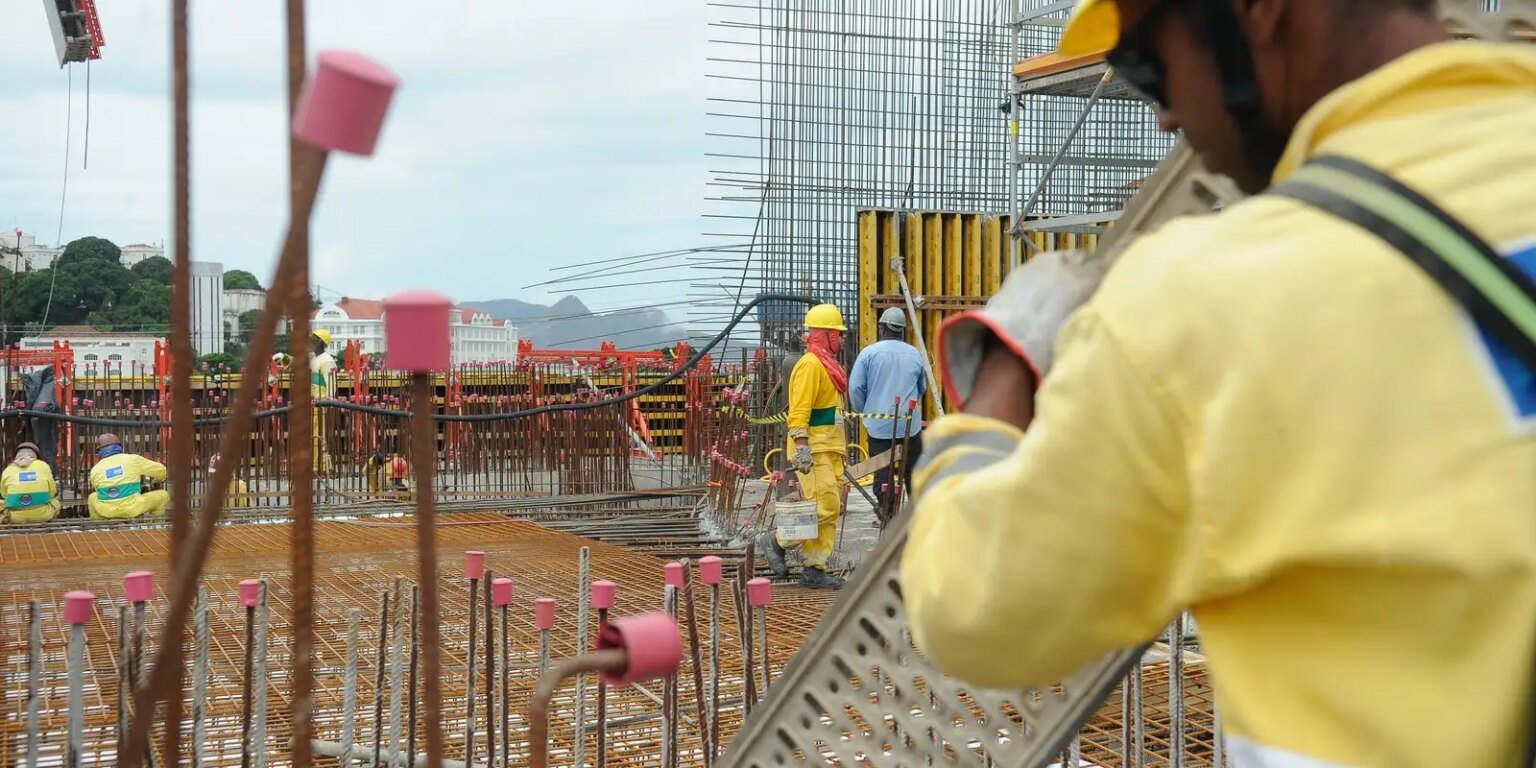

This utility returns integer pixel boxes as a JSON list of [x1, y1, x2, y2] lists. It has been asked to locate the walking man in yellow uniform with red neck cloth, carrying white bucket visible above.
[[759, 304, 848, 590]]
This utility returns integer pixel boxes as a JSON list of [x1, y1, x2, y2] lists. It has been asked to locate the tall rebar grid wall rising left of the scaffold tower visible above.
[[697, 0, 1012, 348]]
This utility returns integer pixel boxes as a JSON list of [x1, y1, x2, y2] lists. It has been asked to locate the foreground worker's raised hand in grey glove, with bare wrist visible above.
[[938, 250, 1109, 411]]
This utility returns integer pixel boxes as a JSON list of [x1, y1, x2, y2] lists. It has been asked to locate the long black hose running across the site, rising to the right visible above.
[[0, 293, 817, 429]]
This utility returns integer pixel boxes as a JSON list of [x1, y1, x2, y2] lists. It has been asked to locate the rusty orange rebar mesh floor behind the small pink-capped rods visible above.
[[0, 513, 831, 766]]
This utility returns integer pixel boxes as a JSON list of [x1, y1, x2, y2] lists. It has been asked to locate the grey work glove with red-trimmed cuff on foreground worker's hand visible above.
[[938, 250, 1109, 404]]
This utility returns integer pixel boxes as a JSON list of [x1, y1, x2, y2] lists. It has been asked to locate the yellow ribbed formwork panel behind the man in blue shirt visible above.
[[857, 209, 1098, 419]]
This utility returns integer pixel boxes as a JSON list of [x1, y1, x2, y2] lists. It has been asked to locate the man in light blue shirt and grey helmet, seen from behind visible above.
[[848, 307, 928, 511]]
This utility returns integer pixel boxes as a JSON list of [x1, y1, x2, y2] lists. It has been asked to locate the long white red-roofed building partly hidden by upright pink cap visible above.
[[310, 296, 518, 364]]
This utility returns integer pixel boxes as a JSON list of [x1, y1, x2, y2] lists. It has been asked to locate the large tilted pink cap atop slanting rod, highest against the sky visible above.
[[293, 51, 399, 155]]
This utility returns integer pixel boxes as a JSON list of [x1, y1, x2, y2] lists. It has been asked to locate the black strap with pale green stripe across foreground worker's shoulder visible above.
[[1266, 155, 1536, 372]]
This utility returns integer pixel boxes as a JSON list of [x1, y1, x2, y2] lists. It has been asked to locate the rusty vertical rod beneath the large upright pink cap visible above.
[[410, 373, 442, 766]]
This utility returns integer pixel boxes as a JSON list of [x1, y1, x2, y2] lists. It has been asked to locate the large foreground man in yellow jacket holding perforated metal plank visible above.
[[902, 0, 1536, 768]]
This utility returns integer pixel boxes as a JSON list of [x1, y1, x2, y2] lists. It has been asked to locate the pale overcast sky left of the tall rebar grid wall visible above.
[[0, 0, 710, 307]]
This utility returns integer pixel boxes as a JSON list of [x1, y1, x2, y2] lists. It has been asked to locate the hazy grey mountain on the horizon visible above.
[[464, 296, 688, 349]]
